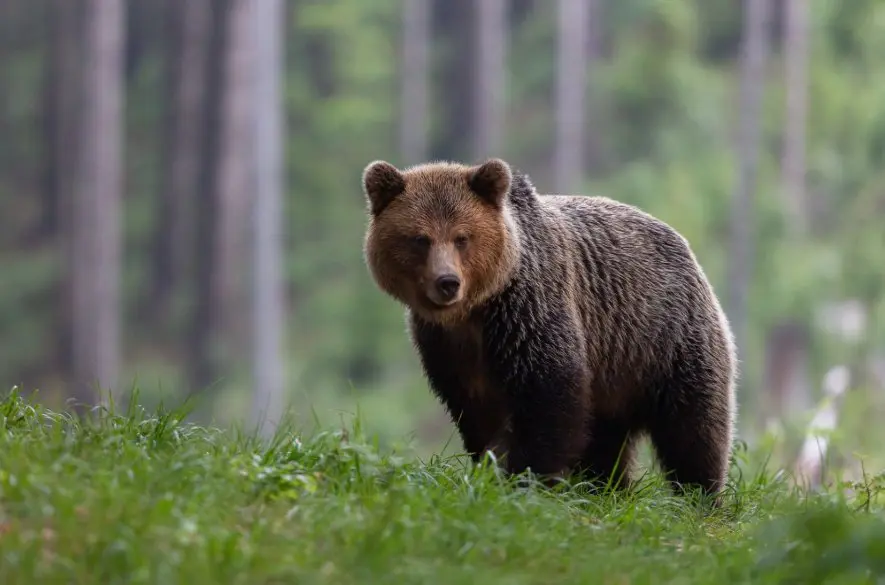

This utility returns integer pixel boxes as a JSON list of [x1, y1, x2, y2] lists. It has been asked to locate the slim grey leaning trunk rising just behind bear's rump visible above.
[[728, 0, 769, 374]]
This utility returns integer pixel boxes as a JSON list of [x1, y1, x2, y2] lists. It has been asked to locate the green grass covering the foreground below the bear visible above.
[[0, 395, 885, 585]]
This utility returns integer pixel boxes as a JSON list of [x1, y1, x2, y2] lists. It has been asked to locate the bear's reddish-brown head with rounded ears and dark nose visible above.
[[363, 159, 519, 325]]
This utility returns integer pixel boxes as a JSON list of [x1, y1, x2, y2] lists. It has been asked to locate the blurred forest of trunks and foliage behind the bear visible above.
[[0, 0, 885, 480]]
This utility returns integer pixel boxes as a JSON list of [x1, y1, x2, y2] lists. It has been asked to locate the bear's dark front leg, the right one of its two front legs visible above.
[[505, 367, 589, 476]]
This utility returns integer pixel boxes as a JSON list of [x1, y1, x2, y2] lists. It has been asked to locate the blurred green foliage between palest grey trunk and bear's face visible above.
[[286, 0, 408, 394]]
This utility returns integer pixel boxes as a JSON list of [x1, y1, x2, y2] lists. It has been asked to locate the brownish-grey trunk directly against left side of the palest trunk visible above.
[[191, 0, 254, 389]]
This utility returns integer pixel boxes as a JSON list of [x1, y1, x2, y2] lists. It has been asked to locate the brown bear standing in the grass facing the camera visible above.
[[363, 159, 737, 493]]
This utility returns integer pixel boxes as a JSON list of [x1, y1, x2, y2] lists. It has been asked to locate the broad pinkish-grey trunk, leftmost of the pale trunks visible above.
[[71, 0, 124, 403]]
